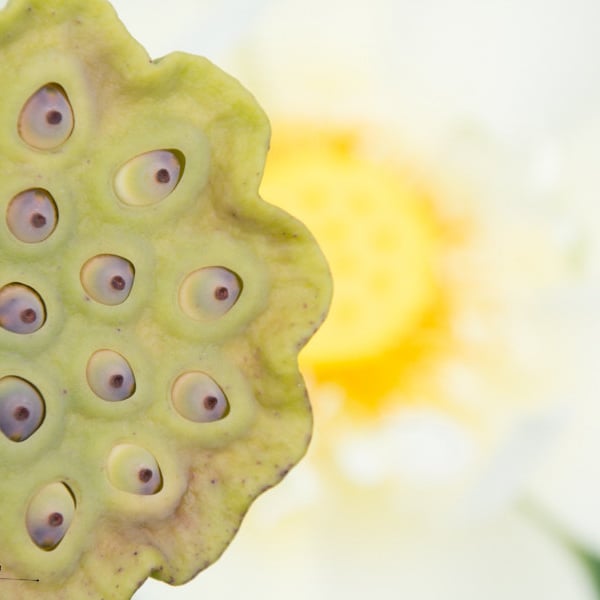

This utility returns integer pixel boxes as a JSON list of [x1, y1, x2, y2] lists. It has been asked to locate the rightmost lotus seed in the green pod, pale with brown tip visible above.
[[179, 267, 242, 321]]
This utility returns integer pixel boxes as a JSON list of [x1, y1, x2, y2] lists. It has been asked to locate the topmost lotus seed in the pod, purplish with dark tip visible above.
[[17, 83, 75, 150]]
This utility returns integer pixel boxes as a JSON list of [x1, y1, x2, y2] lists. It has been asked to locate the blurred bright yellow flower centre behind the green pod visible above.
[[261, 126, 445, 418]]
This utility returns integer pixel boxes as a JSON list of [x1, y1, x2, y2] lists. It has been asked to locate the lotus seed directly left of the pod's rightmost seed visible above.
[[80, 254, 135, 306]]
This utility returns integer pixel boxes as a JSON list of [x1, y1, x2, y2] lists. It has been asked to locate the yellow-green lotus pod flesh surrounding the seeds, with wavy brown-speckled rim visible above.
[[0, 0, 331, 600]]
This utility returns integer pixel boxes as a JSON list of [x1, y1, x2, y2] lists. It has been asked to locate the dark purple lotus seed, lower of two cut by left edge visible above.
[[0, 375, 46, 442]]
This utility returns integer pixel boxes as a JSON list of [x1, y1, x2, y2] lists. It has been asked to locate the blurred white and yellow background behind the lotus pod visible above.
[[84, 0, 600, 600]]
